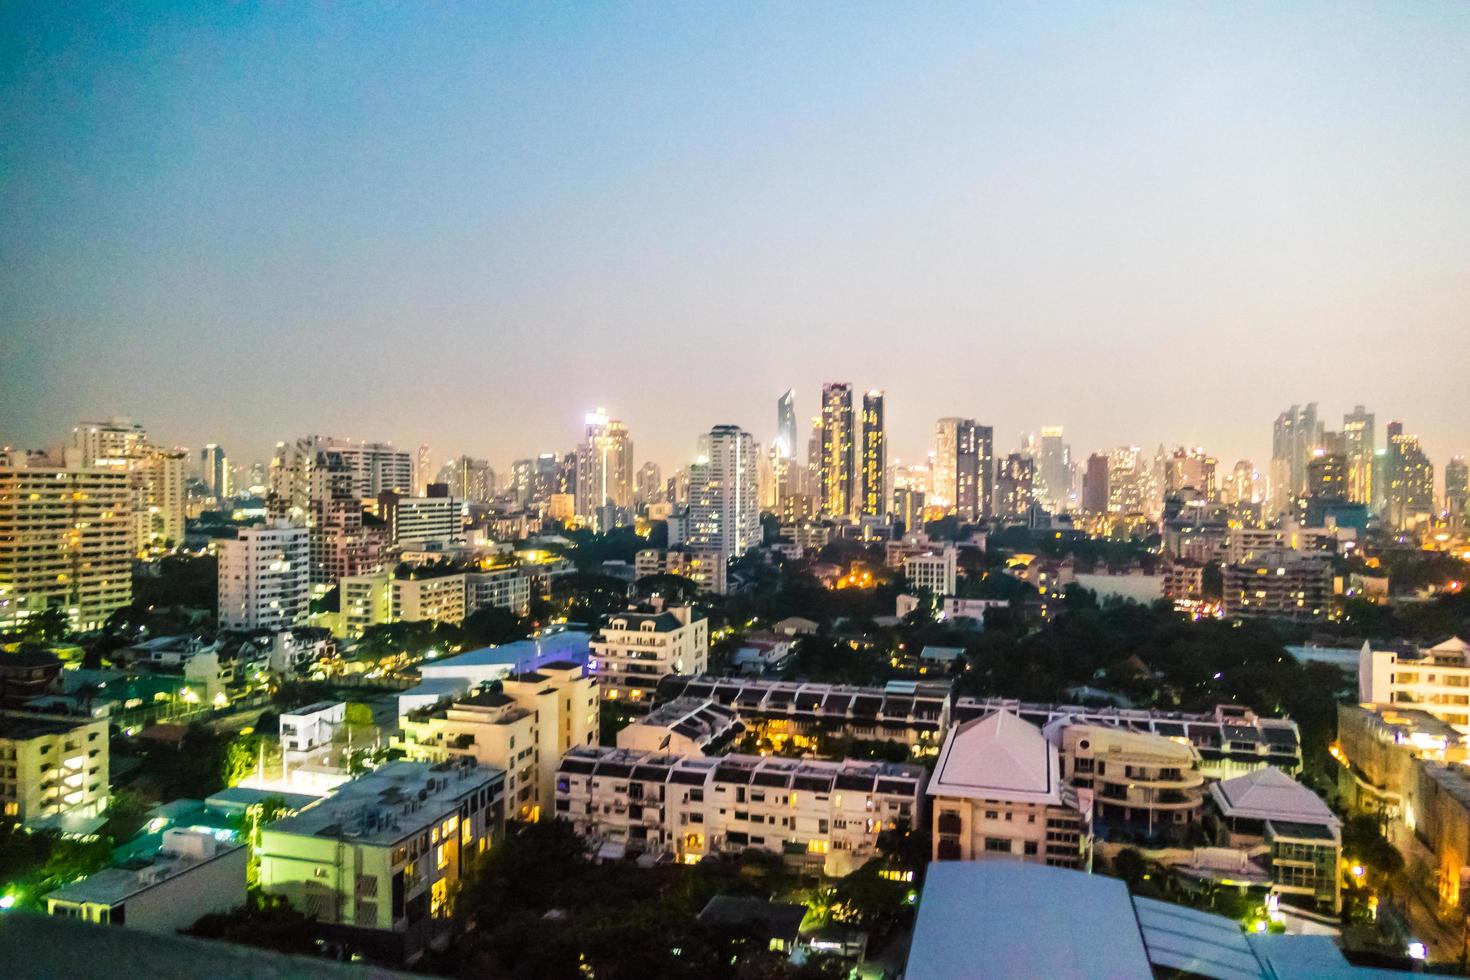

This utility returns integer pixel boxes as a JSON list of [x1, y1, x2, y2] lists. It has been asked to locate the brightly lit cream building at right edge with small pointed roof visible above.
[[1358, 636, 1470, 735]]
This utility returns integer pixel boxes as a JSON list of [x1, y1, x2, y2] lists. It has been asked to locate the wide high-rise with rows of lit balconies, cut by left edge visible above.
[[0, 453, 135, 632]]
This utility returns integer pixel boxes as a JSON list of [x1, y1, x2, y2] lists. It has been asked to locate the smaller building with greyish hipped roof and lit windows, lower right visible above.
[[1210, 765, 1342, 914]]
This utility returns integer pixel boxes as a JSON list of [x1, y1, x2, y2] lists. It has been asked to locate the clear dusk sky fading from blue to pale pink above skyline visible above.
[[0, 1, 1470, 467]]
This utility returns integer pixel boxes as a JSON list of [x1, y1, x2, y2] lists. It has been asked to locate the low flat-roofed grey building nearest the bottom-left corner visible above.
[[46, 827, 248, 936]]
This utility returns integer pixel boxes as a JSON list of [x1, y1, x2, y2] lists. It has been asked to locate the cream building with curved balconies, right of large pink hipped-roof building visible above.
[[1060, 724, 1205, 837]]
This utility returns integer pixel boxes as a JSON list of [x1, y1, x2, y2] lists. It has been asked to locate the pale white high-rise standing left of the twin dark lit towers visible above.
[[688, 425, 760, 575]]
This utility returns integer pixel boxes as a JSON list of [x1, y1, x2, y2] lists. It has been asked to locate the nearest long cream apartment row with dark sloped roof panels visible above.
[[556, 746, 925, 876]]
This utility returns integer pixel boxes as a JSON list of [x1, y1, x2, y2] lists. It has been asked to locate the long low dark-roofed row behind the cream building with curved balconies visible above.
[[954, 698, 1301, 779]]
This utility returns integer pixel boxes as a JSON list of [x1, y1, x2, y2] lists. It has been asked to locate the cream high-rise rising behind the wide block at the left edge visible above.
[[72, 419, 188, 554]]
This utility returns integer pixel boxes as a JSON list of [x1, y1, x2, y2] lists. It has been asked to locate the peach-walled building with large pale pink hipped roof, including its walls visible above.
[[928, 711, 1092, 868]]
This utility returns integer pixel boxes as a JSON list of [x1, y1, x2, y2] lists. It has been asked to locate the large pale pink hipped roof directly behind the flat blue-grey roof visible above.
[[929, 710, 1061, 805]]
